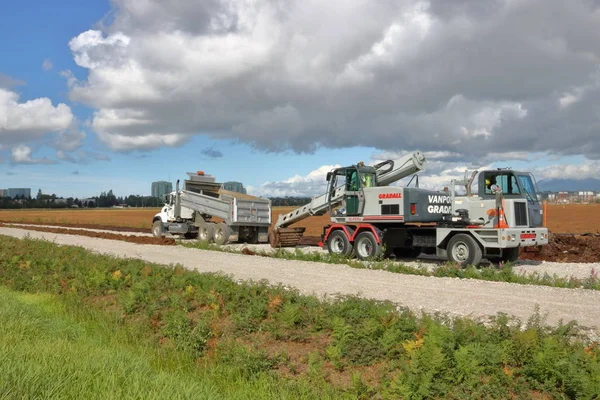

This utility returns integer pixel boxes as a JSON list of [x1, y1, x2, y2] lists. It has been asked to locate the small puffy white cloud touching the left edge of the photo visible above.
[[0, 88, 73, 144]]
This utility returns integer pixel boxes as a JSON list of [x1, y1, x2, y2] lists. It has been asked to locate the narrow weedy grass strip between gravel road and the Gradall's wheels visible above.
[[179, 241, 600, 290]]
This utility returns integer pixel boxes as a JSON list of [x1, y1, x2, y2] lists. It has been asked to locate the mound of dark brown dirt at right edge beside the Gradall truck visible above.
[[519, 233, 600, 262]]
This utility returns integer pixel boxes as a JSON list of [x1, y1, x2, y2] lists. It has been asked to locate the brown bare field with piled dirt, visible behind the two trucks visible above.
[[0, 203, 600, 263]]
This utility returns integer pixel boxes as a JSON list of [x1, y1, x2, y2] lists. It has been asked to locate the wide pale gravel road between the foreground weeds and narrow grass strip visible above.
[[0, 228, 600, 334]]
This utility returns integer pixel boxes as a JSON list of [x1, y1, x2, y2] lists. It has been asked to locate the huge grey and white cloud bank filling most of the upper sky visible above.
[[64, 0, 600, 161]]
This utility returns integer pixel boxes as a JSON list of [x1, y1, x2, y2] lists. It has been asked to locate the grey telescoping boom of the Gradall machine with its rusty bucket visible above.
[[271, 151, 426, 247]]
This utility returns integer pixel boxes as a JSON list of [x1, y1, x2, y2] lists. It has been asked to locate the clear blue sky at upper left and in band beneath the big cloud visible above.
[[0, 0, 380, 197]]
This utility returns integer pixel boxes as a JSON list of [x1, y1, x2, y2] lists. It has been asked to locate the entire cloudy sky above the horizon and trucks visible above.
[[0, 0, 600, 198]]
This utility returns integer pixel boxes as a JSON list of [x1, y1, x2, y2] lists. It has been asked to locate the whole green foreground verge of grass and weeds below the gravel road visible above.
[[0, 236, 600, 399]]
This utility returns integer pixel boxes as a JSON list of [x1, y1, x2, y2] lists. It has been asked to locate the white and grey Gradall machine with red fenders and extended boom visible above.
[[270, 151, 548, 265]]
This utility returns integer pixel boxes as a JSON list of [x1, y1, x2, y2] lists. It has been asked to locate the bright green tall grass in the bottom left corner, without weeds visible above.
[[0, 287, 341, 399]]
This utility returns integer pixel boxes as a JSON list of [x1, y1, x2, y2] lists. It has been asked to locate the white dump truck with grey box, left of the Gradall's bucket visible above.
[[152, 171, 271, 245]]
